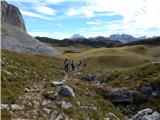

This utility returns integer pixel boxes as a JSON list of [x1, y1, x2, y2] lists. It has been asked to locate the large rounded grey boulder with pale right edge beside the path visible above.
[[59, 86, 75, 98]]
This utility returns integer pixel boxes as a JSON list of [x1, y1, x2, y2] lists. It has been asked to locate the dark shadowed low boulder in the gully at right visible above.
[[106, 89, 134, 104]]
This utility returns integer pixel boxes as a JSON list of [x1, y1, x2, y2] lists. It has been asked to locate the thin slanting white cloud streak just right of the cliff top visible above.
[[21, 10, 51, 20]]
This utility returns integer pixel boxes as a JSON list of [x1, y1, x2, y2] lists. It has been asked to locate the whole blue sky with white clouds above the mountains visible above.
[[7, 0, 160, 39]]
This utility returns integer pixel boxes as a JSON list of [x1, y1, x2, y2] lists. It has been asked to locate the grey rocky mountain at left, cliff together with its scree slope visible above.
[[1, 1, 59, 56]]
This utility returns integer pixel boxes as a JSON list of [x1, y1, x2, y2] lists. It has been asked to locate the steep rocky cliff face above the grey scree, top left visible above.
[[1, 1, 26, 31]]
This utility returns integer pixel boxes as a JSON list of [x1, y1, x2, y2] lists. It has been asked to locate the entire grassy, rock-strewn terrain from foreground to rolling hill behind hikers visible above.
[[2, 46, 160, 120]]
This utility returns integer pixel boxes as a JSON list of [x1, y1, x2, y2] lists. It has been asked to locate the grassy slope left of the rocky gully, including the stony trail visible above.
[[2, 51, 124, 120]]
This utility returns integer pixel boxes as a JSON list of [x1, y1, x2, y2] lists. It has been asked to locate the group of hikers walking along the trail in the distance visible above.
[[64, 58, 86, 73]]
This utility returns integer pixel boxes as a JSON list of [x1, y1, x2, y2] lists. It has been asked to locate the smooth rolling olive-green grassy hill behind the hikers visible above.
[[60, 45, 160, 71]]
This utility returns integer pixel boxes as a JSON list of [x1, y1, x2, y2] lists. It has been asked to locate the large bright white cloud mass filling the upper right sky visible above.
[[67, 0, 160, 36]]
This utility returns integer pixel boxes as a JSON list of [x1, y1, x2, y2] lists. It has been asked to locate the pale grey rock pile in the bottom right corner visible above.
[[129, 108, 160, 120]]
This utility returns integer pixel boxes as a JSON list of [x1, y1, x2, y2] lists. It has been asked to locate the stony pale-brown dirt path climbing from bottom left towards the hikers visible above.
[[11, 74, 69, 120]]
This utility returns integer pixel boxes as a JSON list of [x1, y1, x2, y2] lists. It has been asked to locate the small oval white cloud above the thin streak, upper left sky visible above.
[[34, 5, 56, 15]]
